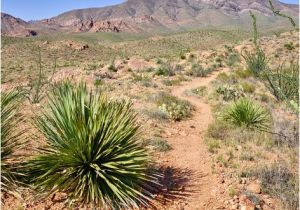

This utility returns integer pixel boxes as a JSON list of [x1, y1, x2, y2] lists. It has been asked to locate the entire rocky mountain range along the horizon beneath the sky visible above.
[[1, 0, 299, 36]]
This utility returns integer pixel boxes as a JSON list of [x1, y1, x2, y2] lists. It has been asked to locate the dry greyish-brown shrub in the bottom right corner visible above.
[[252, 163, 299, 210]]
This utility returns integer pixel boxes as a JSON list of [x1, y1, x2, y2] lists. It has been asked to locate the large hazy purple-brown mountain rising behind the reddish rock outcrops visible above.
[[51, 0, 298, 31]]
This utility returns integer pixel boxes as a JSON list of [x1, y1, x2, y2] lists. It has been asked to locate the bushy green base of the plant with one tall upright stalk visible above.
[[242, 49, 268, 76]]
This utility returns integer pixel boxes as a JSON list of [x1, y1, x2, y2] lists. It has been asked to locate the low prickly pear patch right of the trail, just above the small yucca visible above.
[[216, 85, 245, 101]]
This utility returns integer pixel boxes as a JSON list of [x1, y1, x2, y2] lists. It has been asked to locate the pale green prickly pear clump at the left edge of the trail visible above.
[[153, 92, 193, 121]]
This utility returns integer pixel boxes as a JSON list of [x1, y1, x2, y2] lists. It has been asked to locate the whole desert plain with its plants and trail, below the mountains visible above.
[[1, 1, 299, 210]]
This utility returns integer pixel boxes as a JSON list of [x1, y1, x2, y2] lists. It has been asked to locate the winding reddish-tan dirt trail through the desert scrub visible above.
[[159, 71, 227, 210]]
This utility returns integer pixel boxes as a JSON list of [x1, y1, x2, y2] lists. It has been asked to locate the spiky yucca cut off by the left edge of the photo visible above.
[[1, 90, 24, 195]]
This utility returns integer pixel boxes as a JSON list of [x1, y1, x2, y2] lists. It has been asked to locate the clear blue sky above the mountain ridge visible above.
[[1, 0, 299, 21]]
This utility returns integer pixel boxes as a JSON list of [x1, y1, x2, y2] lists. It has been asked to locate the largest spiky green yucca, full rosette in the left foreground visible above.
[[27, 82, 155, 209]]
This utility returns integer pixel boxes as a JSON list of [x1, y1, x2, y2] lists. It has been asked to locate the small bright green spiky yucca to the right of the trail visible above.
[[224, 98, 271, 130]]
